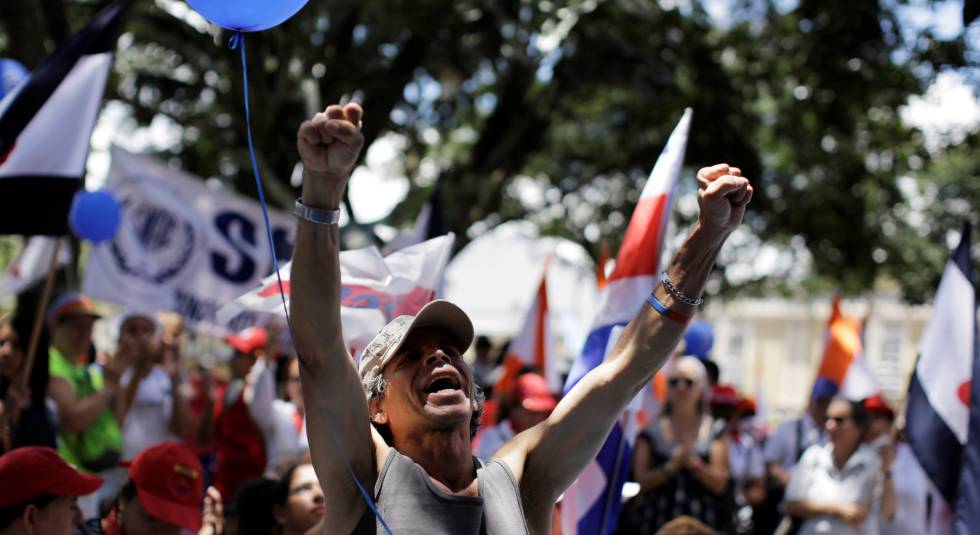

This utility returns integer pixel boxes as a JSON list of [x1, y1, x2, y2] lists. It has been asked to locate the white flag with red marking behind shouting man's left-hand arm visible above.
[[218, 233, 455, 355]]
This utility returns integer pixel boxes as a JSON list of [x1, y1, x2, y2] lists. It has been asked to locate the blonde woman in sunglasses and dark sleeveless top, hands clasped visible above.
[[619, 357, 732, 535]]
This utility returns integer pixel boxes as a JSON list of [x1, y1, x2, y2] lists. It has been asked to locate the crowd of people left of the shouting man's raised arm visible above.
[[0, 294, 323, 535]]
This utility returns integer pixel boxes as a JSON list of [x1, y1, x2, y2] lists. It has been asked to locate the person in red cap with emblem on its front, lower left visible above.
[[77, 442, 204, 535]]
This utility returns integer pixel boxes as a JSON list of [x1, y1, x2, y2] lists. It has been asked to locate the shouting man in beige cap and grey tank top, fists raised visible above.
[[291, 99, 752, 535]]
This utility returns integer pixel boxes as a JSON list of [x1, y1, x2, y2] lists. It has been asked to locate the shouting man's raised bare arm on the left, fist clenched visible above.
[[290, 104, 376, 533]]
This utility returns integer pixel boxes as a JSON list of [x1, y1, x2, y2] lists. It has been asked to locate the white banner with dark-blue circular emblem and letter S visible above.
[[82, 147, 296, 334]]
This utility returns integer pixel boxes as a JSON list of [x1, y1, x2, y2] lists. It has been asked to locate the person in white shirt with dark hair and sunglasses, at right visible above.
[[786, 398, 894, 535]]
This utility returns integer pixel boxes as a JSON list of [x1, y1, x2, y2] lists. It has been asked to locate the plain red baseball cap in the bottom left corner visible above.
[[0, 446, 102, 508]]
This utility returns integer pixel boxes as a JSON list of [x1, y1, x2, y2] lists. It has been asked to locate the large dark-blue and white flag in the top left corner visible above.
[[0, 1, 123, 236]]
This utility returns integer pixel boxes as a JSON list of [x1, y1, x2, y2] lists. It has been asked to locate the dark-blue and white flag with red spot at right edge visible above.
[[905, 226, 980, 535]]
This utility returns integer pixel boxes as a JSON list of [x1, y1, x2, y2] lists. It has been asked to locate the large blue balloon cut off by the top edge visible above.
[[187, 0, 309, 32]]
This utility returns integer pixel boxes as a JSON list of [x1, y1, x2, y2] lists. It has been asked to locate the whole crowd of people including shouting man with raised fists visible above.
[[0, 103, 928, 535]]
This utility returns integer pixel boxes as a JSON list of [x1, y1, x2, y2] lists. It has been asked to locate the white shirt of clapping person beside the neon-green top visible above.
[[119, 365, 181, 461]]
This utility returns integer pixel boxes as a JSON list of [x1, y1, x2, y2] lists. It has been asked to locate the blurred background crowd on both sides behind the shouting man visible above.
[[0, 294, 928, 534]]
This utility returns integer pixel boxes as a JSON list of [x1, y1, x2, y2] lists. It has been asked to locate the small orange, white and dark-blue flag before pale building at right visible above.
[[814, 297, 879, 401]]
